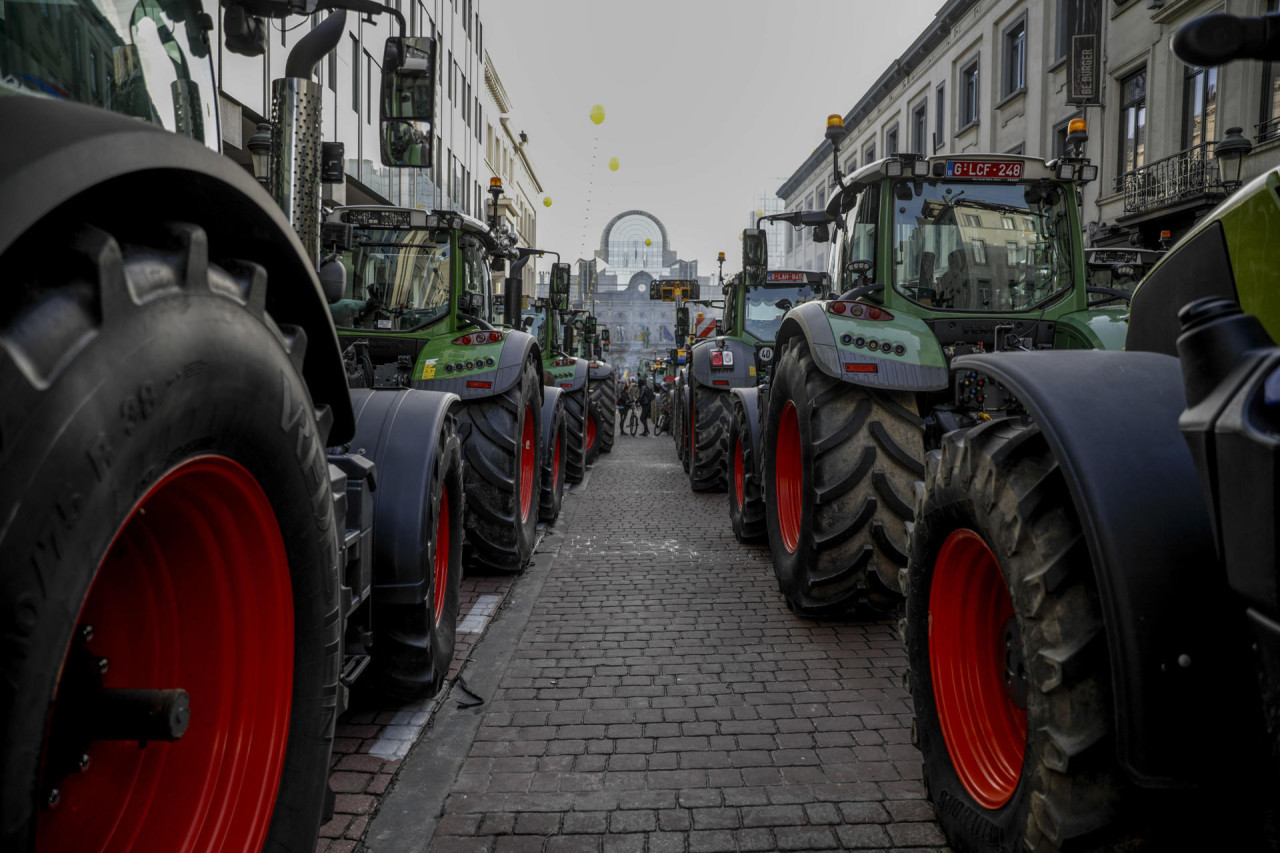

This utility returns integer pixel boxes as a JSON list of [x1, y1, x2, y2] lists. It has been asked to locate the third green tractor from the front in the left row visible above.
[[521, 263, 595, 494]]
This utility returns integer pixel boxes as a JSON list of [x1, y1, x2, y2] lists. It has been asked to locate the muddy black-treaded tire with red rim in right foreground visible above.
[[905, 419, 1141, 853]]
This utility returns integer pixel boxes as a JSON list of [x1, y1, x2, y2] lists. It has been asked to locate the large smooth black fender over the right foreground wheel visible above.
[[954, 350, 1256, 788]]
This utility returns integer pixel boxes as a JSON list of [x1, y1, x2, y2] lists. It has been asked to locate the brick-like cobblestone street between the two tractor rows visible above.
[[353, 437, 946, 853]]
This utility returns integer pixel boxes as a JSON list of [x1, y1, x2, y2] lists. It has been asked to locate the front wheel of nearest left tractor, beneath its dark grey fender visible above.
[[372, 417, 466, 701]]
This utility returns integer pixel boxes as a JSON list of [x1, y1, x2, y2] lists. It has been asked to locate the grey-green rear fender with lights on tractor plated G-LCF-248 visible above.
[[774, 302, 951, 391]]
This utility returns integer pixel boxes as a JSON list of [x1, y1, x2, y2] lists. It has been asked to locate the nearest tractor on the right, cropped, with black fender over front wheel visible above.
[[902, 14, 1280, 853]]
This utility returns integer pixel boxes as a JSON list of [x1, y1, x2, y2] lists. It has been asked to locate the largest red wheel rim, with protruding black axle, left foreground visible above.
[[36, 456, 293, 853]]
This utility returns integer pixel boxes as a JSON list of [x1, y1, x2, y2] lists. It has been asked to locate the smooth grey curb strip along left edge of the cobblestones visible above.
[[362, 469, 591, 853]]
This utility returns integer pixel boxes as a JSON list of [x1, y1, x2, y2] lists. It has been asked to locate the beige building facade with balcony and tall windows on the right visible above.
[[777, 0, 1280, 258]]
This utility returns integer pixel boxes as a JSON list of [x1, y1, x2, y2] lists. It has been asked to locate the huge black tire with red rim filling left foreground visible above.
[[0, 222, 342, 852]]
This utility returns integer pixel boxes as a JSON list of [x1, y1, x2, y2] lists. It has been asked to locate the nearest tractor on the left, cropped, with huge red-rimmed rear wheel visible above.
[[0, 0, 463, 850]]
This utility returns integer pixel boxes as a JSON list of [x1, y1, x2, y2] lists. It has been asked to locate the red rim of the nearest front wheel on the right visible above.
[[929, 530, 1027, 808]]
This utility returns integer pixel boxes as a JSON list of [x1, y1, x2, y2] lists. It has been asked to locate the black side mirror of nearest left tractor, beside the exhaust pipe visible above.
[[379, 37, 435, 169]]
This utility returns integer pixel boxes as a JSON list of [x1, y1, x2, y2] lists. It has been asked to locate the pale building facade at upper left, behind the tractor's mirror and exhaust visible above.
[[212, 0, 536, 249]]
